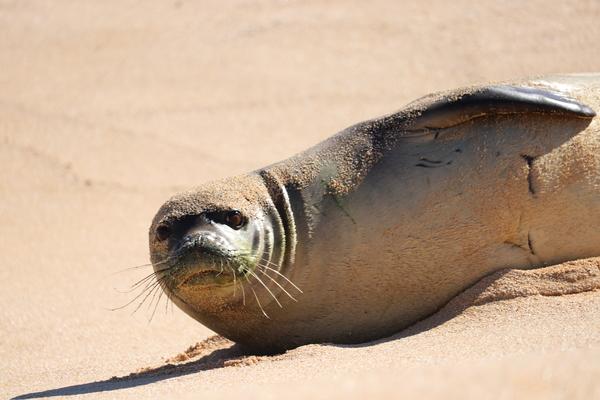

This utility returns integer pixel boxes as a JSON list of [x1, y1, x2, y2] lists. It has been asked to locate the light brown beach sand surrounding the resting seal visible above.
[[0, 0, 600, 398]]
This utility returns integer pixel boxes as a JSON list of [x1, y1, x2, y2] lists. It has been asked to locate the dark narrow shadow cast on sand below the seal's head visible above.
[[13, 344, 255, 400]]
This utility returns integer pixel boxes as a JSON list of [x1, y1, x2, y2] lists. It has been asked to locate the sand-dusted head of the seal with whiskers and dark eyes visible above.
[[149, 174, 286, 329]]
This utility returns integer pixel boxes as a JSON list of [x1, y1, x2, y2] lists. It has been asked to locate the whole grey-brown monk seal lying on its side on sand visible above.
[[150, 75, 600, 351]]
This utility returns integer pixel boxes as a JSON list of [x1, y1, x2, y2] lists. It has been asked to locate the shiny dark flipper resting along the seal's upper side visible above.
[[390, 85, 596, 132]]
